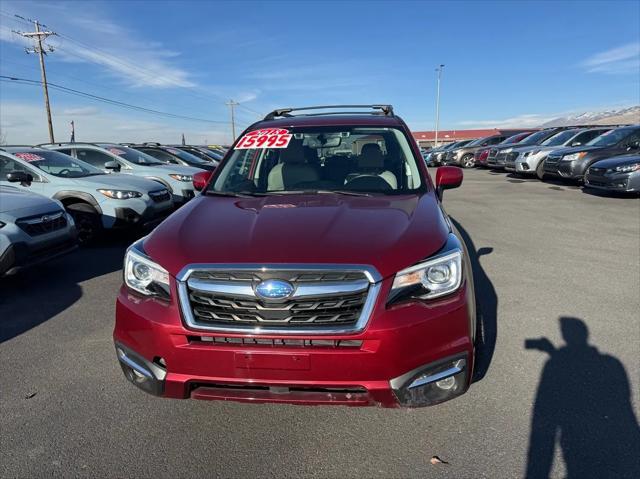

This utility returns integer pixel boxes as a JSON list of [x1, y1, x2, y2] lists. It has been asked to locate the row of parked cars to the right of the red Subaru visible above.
[[436, 125, 640, 193]]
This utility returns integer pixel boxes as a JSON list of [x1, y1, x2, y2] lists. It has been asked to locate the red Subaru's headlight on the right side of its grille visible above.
[[390, 248, 462, 299]]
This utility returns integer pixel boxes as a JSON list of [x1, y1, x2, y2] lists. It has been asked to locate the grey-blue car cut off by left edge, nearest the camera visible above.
[[0, 185, 76, 277]]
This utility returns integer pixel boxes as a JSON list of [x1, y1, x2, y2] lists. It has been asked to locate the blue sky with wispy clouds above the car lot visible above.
[[0, 0, 640, 143]]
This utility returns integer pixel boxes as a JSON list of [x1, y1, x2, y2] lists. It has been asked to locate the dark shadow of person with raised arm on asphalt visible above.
[[525, 317, 640, 479]]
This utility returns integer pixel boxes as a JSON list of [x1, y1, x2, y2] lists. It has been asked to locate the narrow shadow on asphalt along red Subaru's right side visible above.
[[450, 218, 498, 382]]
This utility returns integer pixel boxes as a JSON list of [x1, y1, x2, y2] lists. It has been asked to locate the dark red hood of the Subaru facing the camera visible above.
[[144, 192, 449, 277]]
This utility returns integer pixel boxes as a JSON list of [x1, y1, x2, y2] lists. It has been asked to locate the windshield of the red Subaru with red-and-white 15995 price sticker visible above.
[[207, 127, 423, 195]]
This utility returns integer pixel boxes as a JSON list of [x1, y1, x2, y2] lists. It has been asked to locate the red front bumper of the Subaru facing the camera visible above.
[[114, 280, 475, 407]]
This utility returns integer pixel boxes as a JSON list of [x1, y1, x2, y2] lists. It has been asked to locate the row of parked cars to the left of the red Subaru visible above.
[[0, 143, 225, 276]]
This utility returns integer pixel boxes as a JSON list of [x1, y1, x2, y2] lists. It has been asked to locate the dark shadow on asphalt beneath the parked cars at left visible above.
[[0, 234, 132, 343]]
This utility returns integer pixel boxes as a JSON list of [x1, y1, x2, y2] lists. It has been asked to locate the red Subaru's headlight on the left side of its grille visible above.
[[124, 241, 171, 299]]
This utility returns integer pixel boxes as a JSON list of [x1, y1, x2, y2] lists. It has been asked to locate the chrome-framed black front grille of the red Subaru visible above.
[[179, 268, 378, 332]]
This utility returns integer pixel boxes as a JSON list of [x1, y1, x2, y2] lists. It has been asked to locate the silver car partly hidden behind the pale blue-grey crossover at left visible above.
[[41, 143, 204, 206]]
